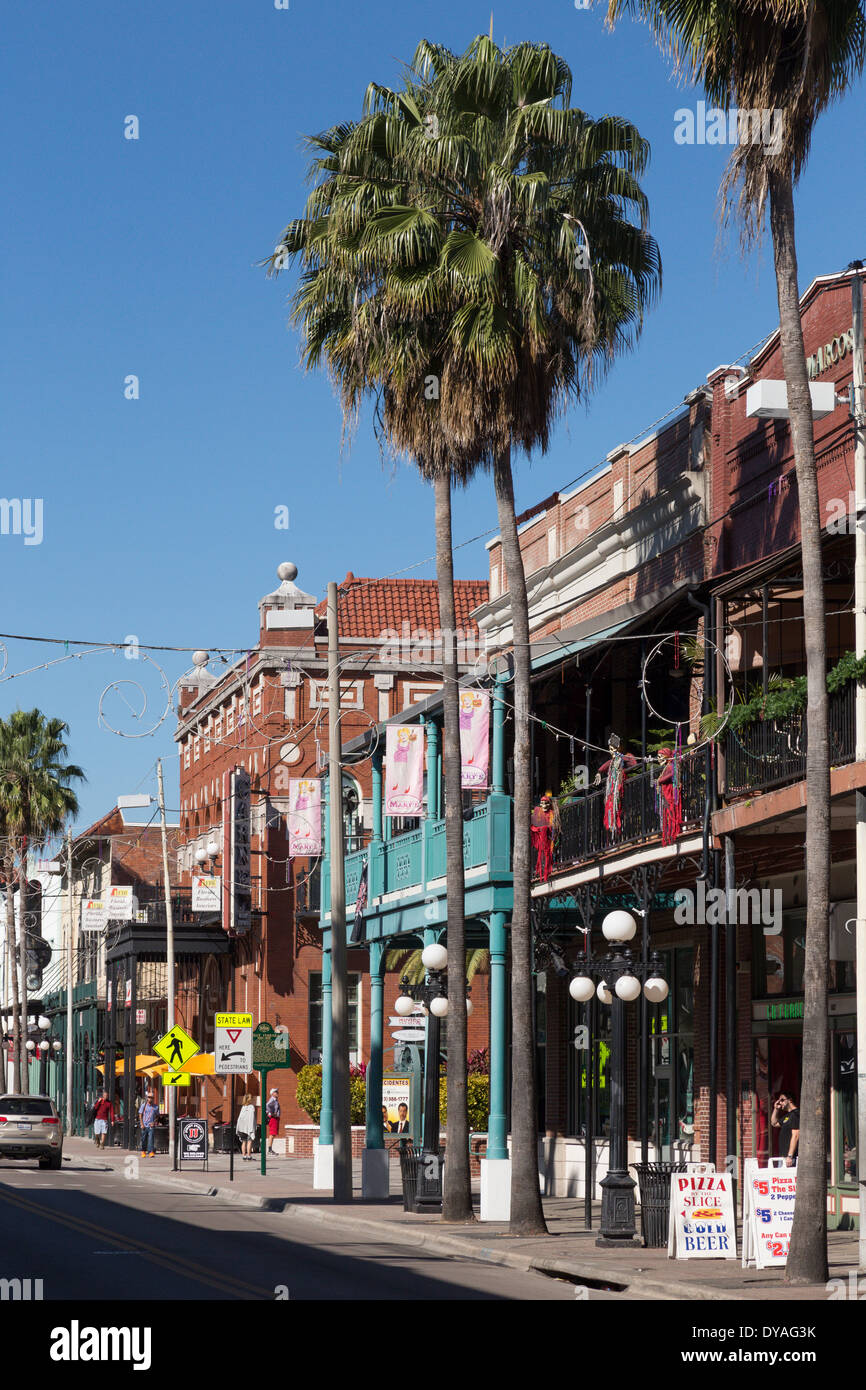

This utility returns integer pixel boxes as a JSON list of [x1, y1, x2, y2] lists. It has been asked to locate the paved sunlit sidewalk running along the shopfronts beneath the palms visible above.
[[64, 1138, 858, 1302]]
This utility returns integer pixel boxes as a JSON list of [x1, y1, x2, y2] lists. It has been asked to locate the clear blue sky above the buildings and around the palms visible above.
[[0, 0, 866, 824]]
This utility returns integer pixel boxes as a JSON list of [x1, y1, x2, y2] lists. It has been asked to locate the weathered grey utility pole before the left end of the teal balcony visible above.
[[328, 582, 352, 1202]]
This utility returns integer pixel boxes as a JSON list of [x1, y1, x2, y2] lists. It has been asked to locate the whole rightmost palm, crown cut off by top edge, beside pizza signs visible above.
[[607, 0, 866, 1284]]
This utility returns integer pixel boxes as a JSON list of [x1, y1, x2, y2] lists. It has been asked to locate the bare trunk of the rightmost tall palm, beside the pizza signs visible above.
[[770, 172, 830, 1284]]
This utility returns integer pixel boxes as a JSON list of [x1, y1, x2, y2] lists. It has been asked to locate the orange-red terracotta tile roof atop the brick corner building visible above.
[[316, 570, 488, 637]]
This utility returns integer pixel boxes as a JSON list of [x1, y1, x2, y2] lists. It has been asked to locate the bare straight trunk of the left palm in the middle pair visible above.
[[434, 473, 474, 1220]]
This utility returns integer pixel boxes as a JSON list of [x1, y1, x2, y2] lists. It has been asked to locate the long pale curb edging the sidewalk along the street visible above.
[[72, 1155, 749, 1302]]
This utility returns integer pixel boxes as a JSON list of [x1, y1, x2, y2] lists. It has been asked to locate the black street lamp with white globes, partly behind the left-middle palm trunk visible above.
[[395, 941, 468, 1211]]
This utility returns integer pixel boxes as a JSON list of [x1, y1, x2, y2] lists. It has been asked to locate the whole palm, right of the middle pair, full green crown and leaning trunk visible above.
[[328, 36, 660, 1234]]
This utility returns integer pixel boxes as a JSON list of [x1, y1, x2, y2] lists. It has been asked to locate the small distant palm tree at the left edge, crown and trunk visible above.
[[0, 709, 85, 1094]]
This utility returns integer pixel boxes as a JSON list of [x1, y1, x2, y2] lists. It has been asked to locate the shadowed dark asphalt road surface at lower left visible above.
[[0, 1161, 603, 1302]]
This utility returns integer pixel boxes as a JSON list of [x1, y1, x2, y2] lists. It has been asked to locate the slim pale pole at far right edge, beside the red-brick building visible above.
[[848, 261, 866, 1270]]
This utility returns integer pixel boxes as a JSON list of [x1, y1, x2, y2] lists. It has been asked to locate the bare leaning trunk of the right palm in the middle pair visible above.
[[493, 450, 548, 1236]]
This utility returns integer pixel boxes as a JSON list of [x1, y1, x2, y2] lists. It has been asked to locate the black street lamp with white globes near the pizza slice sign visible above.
[[569, 909, 669, 1248]]
